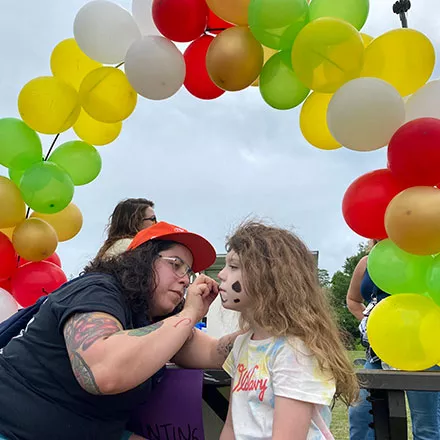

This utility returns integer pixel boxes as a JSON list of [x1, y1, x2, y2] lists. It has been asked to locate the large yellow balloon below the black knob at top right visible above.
[[361, 29, 435, 96]]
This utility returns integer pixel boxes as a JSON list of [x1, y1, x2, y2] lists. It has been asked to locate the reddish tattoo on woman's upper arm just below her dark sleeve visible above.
[[64, 313, 121, 351]]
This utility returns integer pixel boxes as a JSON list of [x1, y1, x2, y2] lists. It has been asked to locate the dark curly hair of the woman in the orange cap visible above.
[[83, 240, 183, 319]]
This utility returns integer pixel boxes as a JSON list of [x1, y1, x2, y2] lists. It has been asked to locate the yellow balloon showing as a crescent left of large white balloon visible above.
[[299, 92, 342, 150]]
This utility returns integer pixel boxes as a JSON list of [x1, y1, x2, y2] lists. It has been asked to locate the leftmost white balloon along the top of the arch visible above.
[[73, 0, 141, 64]]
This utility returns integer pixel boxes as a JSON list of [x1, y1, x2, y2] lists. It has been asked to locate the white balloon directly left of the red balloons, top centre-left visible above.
[[124, 36, 186, 100]]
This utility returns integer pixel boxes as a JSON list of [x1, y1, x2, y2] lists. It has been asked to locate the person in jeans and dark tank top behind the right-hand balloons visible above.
[[347, 240, 440, 440]]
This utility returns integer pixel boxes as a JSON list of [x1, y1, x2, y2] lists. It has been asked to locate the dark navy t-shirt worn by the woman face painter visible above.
[[0, 274, 153, 440]]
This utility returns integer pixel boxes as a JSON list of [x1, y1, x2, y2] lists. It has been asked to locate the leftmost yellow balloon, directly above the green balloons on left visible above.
[[18, 76, 81, 134]]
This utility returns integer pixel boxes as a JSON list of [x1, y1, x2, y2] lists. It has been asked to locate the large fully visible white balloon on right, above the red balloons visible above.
[[327, 78, 405, 151]]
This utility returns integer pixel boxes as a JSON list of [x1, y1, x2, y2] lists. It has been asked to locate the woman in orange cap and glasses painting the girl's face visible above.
[[0, 222, 237, 440]]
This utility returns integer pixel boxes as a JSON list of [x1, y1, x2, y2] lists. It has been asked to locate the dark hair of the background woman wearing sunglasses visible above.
[[96, 199, 154, 260]]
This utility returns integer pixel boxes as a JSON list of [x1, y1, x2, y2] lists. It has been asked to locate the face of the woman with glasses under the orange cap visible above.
[[150, 244, 193, 316]]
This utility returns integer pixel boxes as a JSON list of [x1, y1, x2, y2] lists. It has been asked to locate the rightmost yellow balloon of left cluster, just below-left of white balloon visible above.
[[79, 67, 137, 124]]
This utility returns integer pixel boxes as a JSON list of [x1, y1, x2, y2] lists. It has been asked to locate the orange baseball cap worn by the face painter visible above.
[[128, 222, 216, 272]]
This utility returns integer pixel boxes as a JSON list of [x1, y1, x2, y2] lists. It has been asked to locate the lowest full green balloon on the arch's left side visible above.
[[20, 162, 75, 214]]
